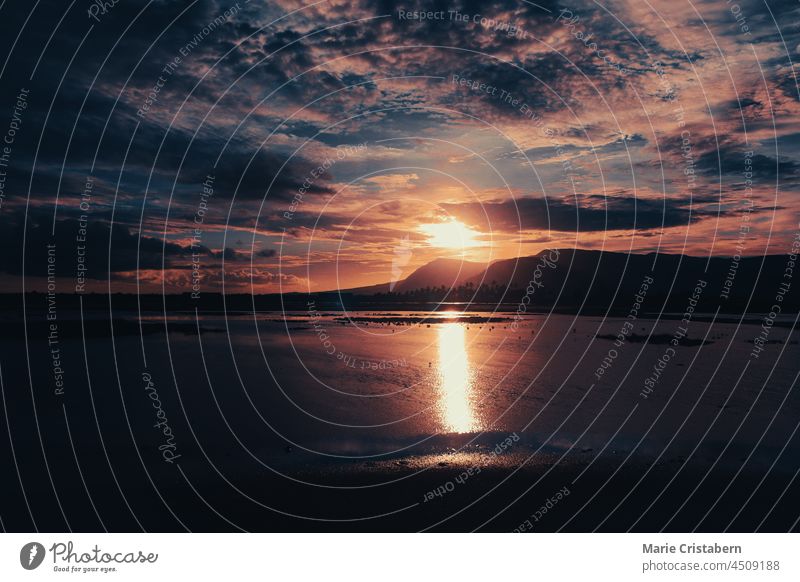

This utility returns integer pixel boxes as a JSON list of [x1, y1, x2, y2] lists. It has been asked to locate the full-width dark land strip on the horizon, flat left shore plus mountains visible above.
[[4, 249, 800, 318]]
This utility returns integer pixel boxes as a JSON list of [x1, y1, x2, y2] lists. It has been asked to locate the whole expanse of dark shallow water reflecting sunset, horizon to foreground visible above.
[[0, 312, 800, 531]]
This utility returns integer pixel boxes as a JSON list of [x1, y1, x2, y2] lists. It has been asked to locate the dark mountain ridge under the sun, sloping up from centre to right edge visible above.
[[350, 249, 800, 313]]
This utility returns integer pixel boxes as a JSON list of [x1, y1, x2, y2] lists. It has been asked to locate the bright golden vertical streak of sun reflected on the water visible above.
[[438, 323, 478, 433]]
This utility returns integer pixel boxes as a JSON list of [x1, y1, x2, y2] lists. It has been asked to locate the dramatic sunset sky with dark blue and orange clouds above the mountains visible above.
[[0, 0, 800, 292]]
